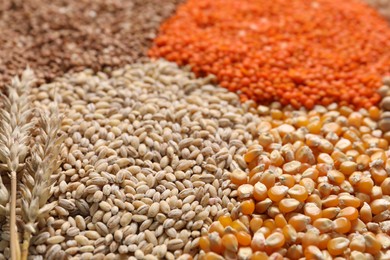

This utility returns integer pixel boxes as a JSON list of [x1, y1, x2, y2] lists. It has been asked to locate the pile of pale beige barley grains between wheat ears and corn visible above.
[[0, 61, 266, 259]]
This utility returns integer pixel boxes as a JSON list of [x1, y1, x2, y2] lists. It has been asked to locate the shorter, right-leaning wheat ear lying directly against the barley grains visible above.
[[21, 100, 65, 260]]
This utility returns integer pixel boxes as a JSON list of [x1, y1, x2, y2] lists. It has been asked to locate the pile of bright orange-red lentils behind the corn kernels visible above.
[[149, 0, 390, 108]]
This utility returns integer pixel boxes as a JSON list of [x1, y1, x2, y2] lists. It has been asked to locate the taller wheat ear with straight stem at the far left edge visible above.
[[0, 69, 35, 259]]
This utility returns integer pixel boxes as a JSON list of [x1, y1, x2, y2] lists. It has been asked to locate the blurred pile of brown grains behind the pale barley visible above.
[[0, 0, 183, 88]]
